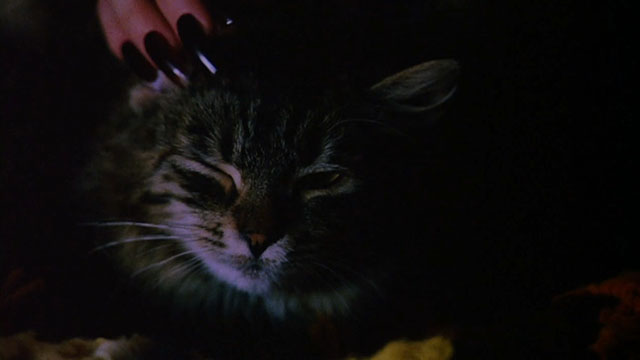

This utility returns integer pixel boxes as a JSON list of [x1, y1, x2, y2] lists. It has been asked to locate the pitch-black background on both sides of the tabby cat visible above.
[[0, 0, 640, 358]]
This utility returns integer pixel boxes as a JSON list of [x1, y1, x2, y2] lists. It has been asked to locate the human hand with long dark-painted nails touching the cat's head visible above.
[[97, 0, 225, 86]]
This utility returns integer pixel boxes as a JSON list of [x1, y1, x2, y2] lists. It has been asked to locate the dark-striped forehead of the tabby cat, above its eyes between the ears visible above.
[[180, 91, 339, 177]]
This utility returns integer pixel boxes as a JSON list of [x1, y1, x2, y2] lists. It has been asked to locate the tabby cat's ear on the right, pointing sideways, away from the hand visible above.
[[369, 59, 460, 114]]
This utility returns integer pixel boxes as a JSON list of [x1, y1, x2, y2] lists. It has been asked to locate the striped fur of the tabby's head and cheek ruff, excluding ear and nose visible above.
[[83, 80, 392, 316]]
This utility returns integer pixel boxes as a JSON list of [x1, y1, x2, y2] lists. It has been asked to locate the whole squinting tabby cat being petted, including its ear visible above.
[[83, 60, 459, 358]]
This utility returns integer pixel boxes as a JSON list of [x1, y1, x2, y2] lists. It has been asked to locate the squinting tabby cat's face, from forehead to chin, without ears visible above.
[[147, 91, 361, 296]]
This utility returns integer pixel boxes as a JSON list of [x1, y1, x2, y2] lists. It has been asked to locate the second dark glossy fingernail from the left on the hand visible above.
[[144, 31, 188, 87]]
